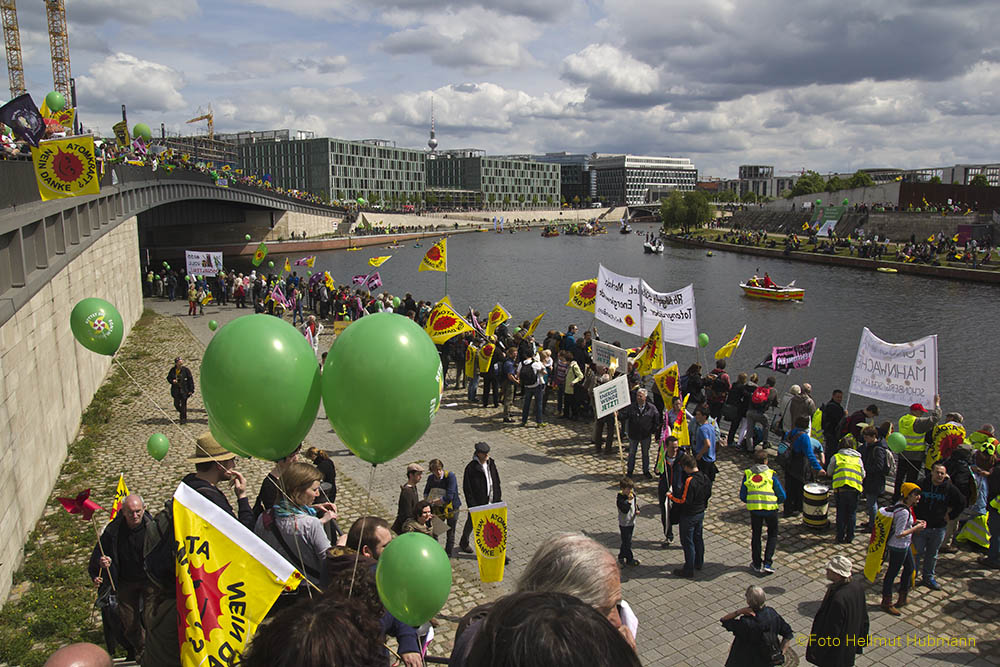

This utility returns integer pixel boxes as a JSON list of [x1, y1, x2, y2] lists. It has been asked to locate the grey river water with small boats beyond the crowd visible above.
[[266, 225, 1000, 431]]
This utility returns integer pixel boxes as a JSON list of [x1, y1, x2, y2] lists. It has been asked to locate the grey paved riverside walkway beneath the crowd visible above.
[[147, 300, 1000, 667]]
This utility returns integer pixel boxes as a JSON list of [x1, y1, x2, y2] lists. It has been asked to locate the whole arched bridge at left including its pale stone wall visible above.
[[0, 161, 342, 600]]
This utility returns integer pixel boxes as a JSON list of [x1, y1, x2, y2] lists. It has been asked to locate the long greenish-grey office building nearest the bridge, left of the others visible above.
[[239, 138, 426, 204]]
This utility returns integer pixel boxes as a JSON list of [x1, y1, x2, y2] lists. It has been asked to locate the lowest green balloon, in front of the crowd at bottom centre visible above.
[[376, 532, 451, 627]]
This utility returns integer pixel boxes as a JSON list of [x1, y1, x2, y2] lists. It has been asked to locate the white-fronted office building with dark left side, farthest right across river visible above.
[[590, 155, 698, 206]]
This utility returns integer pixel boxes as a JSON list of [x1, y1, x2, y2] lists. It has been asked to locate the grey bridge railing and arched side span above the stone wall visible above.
[[0, 161, 343, 325]]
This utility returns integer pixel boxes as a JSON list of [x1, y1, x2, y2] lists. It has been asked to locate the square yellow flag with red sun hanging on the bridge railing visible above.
[[31, 134, 101, 201]]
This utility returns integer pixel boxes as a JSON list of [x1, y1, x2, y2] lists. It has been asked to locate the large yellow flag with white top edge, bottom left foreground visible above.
[[173, 483, 302, 667]]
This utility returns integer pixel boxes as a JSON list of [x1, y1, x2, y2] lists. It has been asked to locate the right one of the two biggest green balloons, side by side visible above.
[[324, 313, 442, 463]]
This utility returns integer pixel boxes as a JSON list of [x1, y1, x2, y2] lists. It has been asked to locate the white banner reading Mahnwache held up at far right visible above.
[[850, 327, 938, 409]]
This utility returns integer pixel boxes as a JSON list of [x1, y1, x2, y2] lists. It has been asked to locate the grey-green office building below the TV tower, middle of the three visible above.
[[427, 149, 560, 209]]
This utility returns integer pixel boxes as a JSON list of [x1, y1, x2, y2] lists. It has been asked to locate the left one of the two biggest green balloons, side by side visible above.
[[201, 315, 318, 461]]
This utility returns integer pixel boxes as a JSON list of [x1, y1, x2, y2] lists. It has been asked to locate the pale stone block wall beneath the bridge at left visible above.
[[0, 218, 143, 600]]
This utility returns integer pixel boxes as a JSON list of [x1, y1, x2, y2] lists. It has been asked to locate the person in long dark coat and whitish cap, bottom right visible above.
[[806, 556, 869, 667]]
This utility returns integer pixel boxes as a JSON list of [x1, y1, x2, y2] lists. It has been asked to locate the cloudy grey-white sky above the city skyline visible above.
[[7, 0, 1000, 177]]
